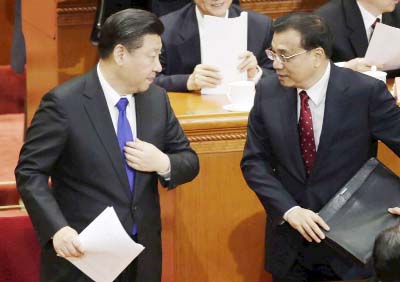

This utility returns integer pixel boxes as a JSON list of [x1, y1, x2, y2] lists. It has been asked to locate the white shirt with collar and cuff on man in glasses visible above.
[[283, 64, 331, 220]]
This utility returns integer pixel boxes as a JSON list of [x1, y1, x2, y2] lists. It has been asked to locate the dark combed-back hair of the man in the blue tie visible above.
[[98, 9, 164, 59]]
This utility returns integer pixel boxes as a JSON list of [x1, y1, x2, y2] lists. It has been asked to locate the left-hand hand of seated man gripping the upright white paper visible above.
[[186, 64, 222, 91]]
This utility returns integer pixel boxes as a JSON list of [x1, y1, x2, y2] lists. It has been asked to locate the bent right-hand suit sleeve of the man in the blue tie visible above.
[[161, 90, 199, 188]]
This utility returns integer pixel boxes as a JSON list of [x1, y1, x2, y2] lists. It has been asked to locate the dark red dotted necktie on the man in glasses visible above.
[[299, 90, 316, 175]]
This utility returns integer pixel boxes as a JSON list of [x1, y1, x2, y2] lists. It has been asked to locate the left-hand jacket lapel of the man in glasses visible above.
[[280, 87, 306, 182]]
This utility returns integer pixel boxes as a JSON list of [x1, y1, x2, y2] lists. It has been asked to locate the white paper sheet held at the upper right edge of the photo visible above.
[[365, 23, 400, 71]]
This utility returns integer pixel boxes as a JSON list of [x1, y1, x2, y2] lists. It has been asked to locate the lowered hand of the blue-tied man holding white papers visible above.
[[53, 226, 84, 258]]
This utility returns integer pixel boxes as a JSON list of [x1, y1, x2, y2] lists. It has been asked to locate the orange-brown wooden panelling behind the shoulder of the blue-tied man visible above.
[[22, 0, 98, 124]]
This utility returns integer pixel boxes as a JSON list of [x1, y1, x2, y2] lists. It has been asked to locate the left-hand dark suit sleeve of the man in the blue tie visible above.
[[15, 93, 68, 246]]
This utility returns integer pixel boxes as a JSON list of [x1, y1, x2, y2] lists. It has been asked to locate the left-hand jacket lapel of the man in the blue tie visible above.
[[84, 68, 131, 197]]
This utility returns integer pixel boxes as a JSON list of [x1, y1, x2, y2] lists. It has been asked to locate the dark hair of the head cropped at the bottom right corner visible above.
[[372, 225, 400, 282]]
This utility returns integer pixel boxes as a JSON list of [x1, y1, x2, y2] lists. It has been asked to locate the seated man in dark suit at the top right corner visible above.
[[316, 0, 400, 74]]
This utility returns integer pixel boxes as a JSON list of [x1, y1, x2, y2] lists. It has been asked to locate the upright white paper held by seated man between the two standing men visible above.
[[201, 12, 247, 95]]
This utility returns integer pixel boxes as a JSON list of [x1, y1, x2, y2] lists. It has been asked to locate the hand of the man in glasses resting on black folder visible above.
[[286, 207, 329, 243]]
